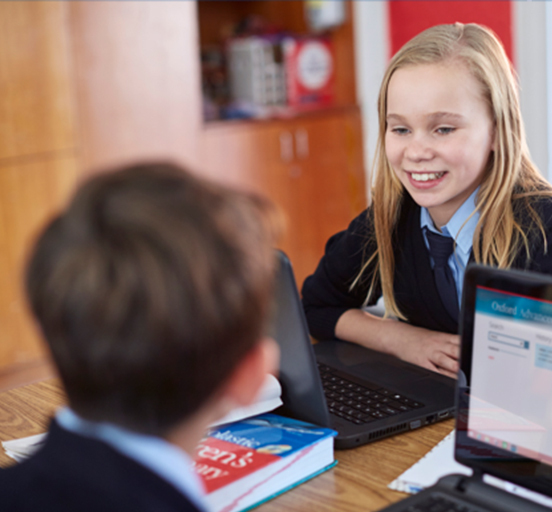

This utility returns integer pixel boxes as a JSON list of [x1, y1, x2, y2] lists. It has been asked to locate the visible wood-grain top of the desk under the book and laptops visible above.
[[0, 380, 454, 512]]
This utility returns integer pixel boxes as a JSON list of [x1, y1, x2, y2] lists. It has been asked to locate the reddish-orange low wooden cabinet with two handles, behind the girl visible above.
[[201, 107, 366, 286]]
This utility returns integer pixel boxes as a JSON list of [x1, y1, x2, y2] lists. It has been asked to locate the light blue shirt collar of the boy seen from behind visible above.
[[56, 407, 207, 511]]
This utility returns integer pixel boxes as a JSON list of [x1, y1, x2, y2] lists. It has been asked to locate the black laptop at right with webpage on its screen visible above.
[[378, 266, 552, 512]]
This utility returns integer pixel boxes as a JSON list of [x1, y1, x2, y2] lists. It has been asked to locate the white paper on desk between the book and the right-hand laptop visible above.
[[387, 432, 472, 494]]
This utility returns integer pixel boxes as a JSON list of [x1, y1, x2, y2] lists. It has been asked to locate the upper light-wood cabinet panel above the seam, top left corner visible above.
[[0, 1, 76, 160]]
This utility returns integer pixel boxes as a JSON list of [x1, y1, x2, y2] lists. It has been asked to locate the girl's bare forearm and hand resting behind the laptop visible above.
[[335, 309, 460, 378]]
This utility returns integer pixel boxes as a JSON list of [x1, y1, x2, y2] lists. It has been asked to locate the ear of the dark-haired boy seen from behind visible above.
[[223, 337, 280, 407]]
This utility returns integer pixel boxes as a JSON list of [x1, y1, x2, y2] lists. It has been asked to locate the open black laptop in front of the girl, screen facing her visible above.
[[269, 251, 455, 448]]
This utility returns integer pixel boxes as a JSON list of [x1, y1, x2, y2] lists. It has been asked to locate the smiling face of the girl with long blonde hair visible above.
[[385, 61, 494, 227]]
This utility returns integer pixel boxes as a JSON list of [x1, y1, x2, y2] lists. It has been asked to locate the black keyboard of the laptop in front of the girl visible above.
[[318, 364, 424, 425]]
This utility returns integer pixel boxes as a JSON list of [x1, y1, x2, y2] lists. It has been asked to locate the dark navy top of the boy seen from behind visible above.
[[0, 412, 205, 512]]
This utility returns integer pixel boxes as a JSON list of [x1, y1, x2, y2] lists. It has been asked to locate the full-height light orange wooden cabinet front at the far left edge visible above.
[[0, 2, 78, 373]]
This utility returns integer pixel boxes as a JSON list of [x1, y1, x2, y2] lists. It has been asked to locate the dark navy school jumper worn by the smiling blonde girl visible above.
[[302, 193, 552, 340]]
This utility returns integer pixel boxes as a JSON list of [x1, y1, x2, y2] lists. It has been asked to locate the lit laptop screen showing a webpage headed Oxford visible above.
[[468, 286, 552, 464]]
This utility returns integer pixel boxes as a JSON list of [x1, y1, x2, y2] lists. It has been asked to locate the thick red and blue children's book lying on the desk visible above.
[[194, 414, 336, 512]]
